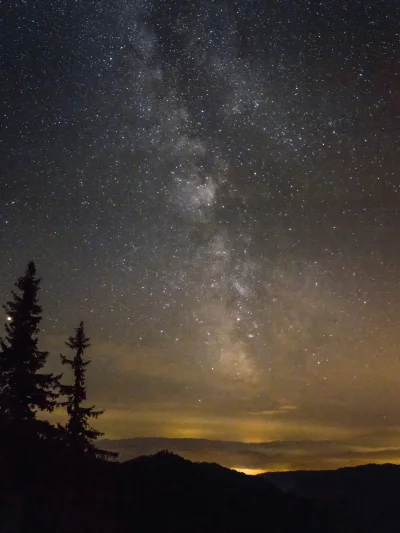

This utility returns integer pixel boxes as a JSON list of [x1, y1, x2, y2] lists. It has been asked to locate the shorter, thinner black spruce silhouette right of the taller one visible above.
[[61, 322, 118, 459]]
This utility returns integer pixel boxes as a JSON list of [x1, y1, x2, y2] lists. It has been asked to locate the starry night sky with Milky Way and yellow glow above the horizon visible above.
[[0, 0, 400, 471]]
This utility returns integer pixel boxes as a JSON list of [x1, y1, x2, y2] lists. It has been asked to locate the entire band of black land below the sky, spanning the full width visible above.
[[0, 446, 400, 533]]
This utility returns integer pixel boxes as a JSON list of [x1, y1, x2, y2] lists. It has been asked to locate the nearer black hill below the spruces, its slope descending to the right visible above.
[[0, 452, 324, 533]]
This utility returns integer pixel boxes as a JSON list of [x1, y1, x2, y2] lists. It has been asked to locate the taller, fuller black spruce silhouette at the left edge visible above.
[[0, 262, 61, 437]]
